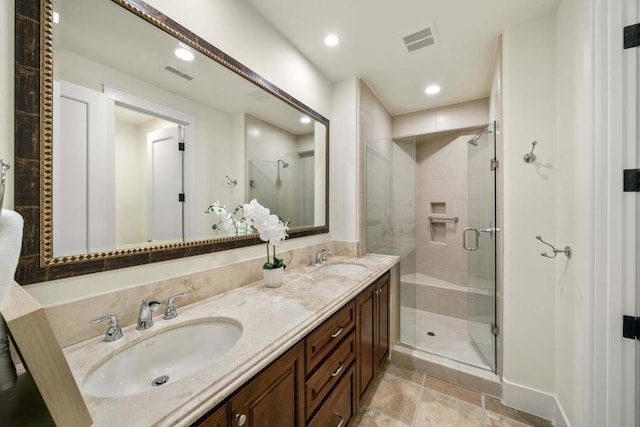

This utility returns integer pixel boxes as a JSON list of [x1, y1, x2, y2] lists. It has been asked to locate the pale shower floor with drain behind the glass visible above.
[[400, 306, 491, 370]]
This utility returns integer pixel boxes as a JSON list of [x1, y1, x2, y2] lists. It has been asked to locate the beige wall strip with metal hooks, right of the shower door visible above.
[[503, 10, 566, 397]]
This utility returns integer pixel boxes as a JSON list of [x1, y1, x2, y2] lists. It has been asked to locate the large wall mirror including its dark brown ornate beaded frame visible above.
[[15, 0, 329, 284]]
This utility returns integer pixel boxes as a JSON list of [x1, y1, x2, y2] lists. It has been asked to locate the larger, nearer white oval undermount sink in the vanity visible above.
[[82, 319, 242, 397]]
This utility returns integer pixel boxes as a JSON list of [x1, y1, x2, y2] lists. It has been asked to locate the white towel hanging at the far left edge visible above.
[[0, 209, 24, 307]]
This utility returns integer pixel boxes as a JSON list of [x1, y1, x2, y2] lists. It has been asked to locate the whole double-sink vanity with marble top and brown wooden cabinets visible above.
[[64, 255, 397, 426]]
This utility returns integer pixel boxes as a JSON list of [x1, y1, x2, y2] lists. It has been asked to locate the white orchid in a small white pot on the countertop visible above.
[[242, 199, 289, 287]]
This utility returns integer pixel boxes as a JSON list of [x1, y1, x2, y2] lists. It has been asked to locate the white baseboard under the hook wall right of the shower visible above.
[[502, 378, 571, 427]]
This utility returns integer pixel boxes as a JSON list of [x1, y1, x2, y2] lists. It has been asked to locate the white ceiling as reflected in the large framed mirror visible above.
[[53, 0, 314, 135]]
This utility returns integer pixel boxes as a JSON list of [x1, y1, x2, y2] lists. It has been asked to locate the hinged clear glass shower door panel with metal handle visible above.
[[462, 122, 498, 372]]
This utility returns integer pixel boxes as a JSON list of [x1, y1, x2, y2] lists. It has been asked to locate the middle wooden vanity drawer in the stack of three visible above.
[[305, 332, 356, 418]]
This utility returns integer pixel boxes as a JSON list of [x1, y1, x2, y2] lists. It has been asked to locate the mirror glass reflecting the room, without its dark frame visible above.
[[52, 0, 327, 257]]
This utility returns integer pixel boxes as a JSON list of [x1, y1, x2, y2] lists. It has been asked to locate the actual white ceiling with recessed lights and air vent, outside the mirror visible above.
[[246, 0, 560, 115]]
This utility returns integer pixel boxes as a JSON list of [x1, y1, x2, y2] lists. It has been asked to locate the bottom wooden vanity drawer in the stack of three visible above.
[[307, 364, 356, 427]]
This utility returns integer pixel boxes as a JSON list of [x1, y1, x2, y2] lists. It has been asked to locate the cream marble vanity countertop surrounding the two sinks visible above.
[[64, 255, 398, 426]]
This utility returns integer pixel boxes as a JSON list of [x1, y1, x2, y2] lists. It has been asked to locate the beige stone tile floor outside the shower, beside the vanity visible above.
[[353, 363, 552, 427]]
